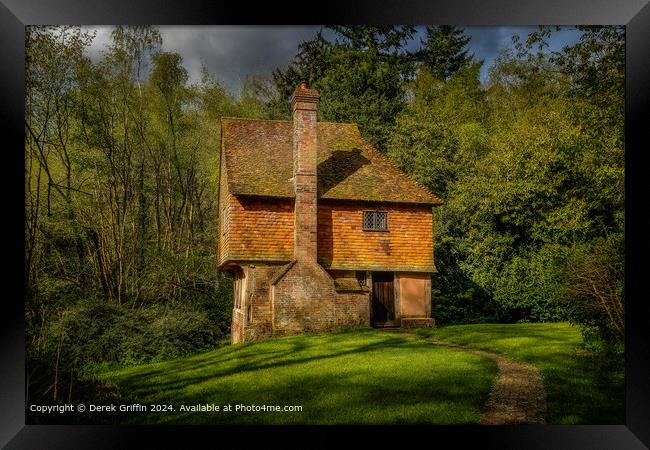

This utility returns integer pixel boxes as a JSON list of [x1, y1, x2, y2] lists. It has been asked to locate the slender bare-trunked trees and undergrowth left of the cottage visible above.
[[25, 26, 246, 400]]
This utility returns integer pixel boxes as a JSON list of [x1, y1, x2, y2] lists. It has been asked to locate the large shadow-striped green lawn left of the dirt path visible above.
[[92, 329, 497, 424]]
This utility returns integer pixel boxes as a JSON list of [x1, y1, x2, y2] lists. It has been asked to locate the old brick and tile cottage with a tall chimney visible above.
[[217, 83, 442, 343]]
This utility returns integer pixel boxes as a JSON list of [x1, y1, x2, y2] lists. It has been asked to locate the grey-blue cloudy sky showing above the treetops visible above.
[[84, 25, 579, 93]]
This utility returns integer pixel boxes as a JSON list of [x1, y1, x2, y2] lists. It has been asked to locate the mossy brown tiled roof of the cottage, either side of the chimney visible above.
[[221, 118, 442, 205]]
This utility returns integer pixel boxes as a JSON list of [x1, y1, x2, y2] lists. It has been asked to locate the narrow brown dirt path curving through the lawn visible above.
[[403, 332, 546, 425]]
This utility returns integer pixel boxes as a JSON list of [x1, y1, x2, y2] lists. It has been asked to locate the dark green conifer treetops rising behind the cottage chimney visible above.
[[268, 25, 472, 151]]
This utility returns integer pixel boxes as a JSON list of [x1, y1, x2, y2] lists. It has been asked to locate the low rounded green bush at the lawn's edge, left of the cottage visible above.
[[45, 300, 222, 371]]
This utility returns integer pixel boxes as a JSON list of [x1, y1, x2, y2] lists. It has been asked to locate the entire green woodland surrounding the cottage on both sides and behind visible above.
[[25, 26, 625, 403]]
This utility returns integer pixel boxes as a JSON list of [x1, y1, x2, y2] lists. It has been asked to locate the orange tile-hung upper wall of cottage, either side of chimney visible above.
[[219, 196, 434, 272]]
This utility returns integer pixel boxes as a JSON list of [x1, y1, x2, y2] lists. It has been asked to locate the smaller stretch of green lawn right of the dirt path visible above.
[[417, 323, 625, 424]]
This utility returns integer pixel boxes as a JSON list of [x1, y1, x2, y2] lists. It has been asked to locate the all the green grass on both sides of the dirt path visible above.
[[92, 323, 624, 424]]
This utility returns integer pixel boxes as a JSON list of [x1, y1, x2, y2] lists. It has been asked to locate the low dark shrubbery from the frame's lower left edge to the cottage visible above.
[[27, 300, 225, 401]]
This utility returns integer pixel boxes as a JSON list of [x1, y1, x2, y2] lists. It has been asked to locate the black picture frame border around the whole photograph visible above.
[[0, 0, 650, 449]]
